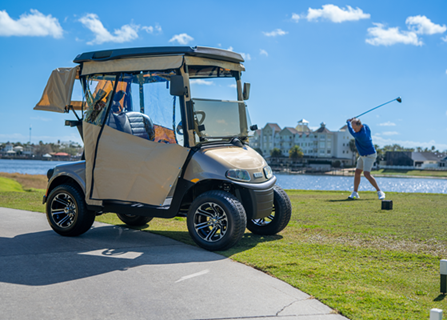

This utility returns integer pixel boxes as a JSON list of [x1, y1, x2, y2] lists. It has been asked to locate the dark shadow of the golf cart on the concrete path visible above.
[[0, 226, 225, 286]]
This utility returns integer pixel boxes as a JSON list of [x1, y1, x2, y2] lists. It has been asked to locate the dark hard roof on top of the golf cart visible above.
[[73, 46, 244, 63]]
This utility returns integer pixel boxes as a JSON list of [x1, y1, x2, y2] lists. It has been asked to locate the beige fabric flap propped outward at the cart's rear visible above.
[[34, 66, 81, 113]]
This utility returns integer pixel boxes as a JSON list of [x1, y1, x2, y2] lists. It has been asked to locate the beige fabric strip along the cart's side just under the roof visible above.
[[82, 56, 183, 75]]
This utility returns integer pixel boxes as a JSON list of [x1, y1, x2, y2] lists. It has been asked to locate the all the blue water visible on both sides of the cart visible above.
[[0, 159, 447, 193]]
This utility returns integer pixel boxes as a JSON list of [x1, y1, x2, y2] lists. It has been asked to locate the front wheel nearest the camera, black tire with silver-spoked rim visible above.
[[187, 190, 247, 251]]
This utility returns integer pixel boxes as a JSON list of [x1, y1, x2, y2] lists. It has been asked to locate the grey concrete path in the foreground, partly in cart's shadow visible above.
[[0, 208, 346, 320]]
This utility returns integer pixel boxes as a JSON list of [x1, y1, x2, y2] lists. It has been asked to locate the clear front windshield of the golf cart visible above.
[[189, 67, 251, 142]]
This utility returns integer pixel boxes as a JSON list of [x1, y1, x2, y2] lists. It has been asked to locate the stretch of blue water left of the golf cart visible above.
[[0, 159, 70, 174]]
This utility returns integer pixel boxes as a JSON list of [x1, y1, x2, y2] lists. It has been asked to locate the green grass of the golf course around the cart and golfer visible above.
[[0, 174, 447, 319]]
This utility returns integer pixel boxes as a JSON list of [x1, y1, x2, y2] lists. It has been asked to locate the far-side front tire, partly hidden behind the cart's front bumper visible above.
[[247, 185, 292, 235]]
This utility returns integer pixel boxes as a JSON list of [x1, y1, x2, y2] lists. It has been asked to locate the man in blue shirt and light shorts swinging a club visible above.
[[347, 118, 385, 200]]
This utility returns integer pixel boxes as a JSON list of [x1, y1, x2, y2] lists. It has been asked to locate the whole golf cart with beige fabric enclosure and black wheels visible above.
[[34, 47, 291, 250]]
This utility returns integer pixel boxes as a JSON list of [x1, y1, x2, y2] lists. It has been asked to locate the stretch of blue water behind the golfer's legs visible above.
[[275, 174, 447, 193]]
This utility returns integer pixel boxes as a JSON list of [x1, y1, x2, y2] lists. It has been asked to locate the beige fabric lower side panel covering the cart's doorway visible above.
[[84, 122, 189, 205]]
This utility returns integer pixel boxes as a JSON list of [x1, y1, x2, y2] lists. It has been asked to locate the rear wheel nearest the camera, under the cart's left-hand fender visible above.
[[46, 184, 96, 237]]
